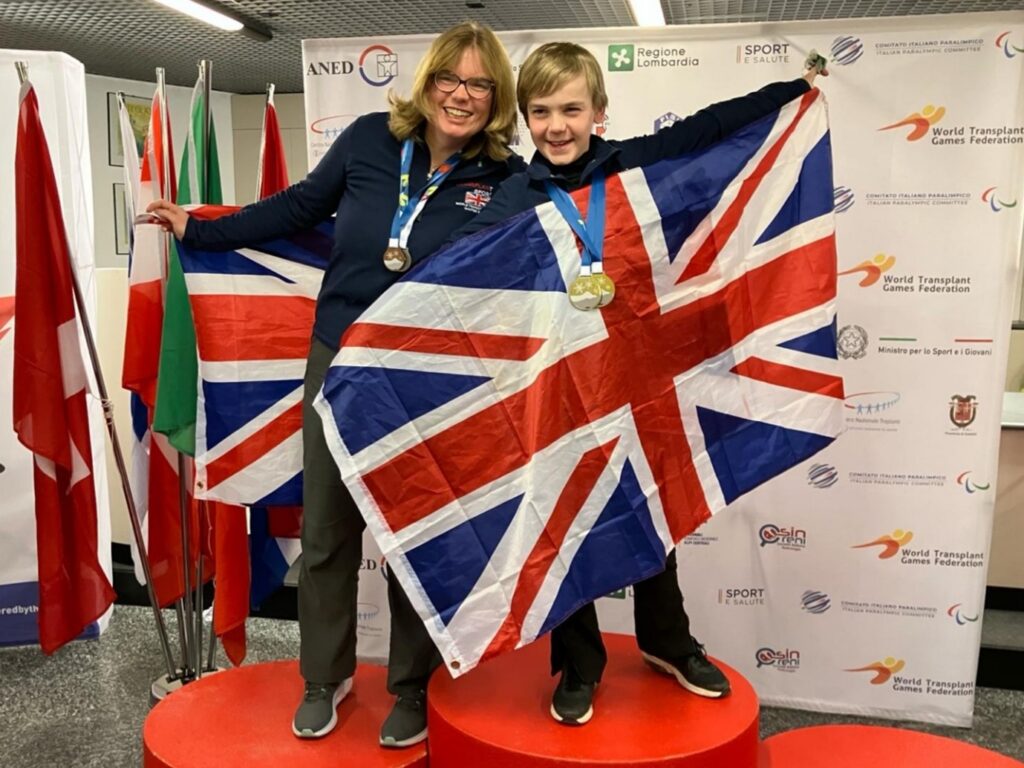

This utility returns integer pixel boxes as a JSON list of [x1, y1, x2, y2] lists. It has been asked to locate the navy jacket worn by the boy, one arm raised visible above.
[[449, 78, 811, 242]]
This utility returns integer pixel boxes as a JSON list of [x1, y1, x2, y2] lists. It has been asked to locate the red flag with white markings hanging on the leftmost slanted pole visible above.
[[14, 83, 115, 653]]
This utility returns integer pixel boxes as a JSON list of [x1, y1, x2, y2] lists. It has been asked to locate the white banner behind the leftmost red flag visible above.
[[0, 50, 111, 645]]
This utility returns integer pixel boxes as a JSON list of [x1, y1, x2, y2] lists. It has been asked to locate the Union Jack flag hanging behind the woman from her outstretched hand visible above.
[[178, 206, 334, 506]]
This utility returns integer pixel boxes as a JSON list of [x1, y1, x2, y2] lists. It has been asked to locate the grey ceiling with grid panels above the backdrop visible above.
[[0, 0, 1024, 93]]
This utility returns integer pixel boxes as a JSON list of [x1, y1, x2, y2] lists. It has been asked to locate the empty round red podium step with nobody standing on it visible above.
[[761, 725, 1024, 768]]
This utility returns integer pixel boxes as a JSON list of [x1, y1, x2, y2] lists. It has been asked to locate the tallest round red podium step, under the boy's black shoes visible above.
[[427, 635, 759, 768]]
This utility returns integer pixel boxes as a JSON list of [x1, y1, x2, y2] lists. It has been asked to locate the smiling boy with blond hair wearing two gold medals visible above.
[[452, 42, 827, 725]]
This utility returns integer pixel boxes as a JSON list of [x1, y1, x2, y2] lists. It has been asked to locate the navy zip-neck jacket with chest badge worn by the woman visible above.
[[181, 113, 526, 349]]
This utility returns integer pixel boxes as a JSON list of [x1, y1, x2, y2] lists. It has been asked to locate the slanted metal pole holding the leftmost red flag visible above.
[[14, 61, 176, 678]]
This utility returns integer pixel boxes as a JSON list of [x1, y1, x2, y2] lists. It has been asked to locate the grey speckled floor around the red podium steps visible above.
[[0, 606, 1024, 768]]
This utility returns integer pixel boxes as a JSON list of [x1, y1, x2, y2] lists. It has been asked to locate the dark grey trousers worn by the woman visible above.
[[299, 339, 441, 694]]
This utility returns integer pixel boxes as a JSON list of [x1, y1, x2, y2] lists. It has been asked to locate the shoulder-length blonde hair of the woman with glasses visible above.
[[388, 22, 516, 160]]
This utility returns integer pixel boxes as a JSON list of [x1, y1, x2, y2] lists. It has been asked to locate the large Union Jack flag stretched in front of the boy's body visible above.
[[316, 91, 843, 675]]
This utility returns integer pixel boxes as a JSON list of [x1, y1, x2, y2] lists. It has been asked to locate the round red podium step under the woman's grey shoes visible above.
[[142, 662, 427, 768]]
